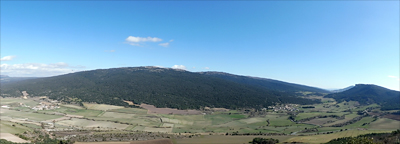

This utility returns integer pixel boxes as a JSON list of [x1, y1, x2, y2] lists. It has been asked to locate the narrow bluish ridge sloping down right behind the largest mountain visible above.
[[200, 72, 330, 93]]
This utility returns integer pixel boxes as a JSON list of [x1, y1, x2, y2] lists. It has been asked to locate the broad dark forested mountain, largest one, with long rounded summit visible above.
[[1, 67, 319, 109]]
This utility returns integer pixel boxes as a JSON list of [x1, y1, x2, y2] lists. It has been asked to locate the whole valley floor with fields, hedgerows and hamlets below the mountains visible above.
[[0, 97, 400, 144]]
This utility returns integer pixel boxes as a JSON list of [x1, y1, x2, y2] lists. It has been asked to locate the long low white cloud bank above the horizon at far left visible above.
[[0, 62, 85, 77]]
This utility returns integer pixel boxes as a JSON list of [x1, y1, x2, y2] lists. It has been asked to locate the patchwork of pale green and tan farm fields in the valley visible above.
[[0, 98, 400, 144]]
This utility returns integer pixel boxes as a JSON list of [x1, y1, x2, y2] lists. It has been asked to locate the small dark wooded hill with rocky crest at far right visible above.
[[325, 84, 400, 110]]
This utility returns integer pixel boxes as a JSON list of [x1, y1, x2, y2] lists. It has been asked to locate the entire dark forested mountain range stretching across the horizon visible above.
[[0, 67, 400, 110]]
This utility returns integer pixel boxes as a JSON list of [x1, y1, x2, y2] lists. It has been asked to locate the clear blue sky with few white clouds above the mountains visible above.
[[0, 1, 400, 90]]
